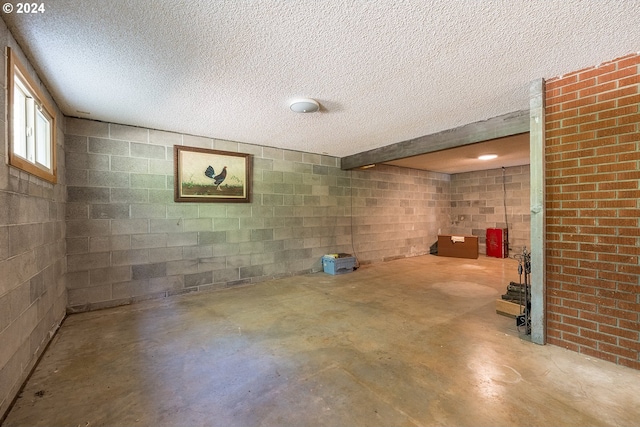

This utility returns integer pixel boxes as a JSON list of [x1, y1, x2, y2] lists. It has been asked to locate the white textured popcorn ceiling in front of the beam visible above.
[[3, 0, 640, 157]]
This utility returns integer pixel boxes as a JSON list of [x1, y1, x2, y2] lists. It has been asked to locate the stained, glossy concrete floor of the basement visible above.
[[4, 255, 640, 427]]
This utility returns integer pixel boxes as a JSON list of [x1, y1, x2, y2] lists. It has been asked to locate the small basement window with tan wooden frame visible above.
[[7, 48, 57, 183]]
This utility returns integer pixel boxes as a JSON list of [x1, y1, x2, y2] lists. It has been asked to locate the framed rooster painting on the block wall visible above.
[[173, 145, 251, 203]]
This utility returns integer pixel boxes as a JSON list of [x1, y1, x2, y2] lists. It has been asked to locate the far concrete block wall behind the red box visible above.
[[449, 165, 531, 255]]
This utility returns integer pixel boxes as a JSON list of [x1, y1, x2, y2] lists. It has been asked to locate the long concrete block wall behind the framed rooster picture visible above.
[[66, 118, 448, 311]]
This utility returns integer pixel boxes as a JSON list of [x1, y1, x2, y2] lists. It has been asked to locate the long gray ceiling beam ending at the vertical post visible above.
[[340, 110, 529, 170]]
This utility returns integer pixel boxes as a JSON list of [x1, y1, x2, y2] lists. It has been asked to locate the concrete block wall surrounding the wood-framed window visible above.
[[0, 31, 67, 421]]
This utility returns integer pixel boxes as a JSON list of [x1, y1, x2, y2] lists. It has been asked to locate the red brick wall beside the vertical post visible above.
[[545, 54, 640, 369]]
